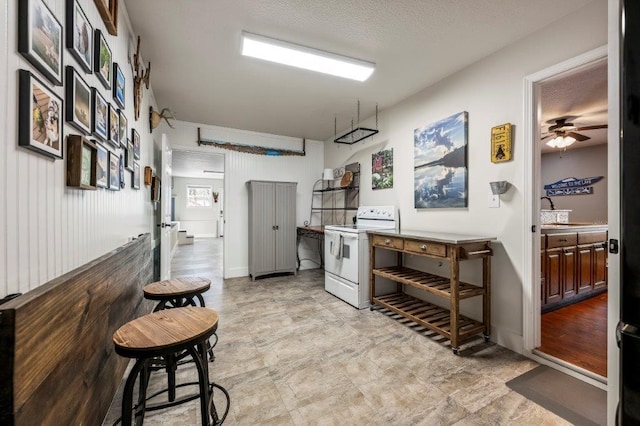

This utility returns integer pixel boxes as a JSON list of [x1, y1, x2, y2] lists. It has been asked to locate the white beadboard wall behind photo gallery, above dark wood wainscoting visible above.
[[0, 0, 154, 297]]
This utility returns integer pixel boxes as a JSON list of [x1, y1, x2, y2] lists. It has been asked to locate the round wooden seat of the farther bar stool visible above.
[[142, 277, 211, 312]]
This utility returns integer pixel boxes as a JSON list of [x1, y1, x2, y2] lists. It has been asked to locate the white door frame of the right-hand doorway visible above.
[[522, 46, 607, 376]]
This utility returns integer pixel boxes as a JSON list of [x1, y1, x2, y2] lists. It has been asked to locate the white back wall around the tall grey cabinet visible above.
[[166, 121, 324, 278]]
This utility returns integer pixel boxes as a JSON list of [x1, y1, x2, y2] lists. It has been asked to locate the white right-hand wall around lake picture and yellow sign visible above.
[[325, 1, 607, 351]]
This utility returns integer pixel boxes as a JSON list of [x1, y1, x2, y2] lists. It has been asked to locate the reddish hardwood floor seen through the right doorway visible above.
[[538, 293, 607, 377]]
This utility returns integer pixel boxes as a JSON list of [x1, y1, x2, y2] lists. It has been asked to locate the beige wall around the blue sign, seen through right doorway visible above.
[[540, 145, 609, 223]]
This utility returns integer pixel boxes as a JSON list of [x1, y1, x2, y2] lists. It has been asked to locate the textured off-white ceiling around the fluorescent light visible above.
[[121, 0, 591, 140]]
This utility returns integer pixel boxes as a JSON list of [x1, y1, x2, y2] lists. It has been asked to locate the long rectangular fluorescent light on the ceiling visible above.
[[242, 31, 376, 81]]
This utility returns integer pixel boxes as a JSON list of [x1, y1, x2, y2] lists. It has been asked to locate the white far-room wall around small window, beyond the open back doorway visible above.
[[171, 177, 224, 237]]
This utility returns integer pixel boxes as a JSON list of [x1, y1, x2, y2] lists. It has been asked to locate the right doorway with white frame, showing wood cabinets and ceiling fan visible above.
[[523, 47, 608, 387]]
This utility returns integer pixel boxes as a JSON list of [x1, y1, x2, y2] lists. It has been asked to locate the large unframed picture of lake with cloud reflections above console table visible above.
[[413, 111, 469, 209]]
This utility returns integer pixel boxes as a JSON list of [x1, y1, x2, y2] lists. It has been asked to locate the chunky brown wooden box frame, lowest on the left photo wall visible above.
[[67, 135, 98, 190]]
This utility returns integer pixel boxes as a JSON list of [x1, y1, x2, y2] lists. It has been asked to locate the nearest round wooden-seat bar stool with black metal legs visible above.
[[113, 306, 230, 425]]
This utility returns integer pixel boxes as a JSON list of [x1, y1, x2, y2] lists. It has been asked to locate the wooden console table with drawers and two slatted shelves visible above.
[[368, 230, 495, 355]]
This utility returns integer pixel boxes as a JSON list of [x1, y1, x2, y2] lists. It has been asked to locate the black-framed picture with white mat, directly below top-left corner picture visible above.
[[18, 70, 63, 158]]
